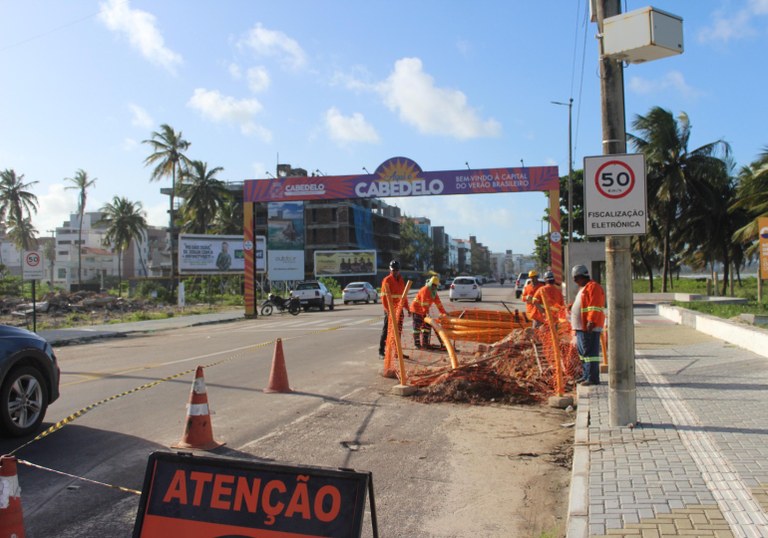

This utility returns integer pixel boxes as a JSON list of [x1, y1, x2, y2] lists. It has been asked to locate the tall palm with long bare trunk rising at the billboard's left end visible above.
[[142, 124, 190, 292]]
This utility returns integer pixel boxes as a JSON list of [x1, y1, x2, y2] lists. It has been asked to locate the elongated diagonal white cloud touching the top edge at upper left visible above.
[[99, 0, 183, 74]]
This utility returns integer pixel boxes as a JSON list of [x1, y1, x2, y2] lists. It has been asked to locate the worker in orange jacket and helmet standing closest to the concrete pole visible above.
[[571, 265, 605, 386]]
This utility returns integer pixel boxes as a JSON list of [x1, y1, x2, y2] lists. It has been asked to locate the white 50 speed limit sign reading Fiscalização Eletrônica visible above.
[[584, 153, 648, 236]]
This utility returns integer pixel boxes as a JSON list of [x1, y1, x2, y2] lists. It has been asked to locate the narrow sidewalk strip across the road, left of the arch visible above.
[[38, 308, 245, 346]]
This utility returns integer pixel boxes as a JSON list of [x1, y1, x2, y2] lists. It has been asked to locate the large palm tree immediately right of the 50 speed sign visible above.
[[628, 107, 730, 292]]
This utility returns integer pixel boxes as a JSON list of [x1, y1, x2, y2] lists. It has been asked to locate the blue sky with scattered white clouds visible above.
[[0, 0, 768, 254]]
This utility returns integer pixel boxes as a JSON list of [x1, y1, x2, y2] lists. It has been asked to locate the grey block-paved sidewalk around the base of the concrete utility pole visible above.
[[568, 308, 768, 538]]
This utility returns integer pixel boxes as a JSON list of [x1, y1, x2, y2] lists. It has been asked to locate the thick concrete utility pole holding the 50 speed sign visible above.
[[596, 0, 637, 426]]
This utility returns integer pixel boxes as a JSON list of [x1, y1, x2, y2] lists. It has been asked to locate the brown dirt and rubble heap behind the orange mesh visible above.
[[408, 329, 578, 404]]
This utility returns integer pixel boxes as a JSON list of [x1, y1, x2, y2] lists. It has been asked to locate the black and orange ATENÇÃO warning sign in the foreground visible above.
[[133, 452, 372, 538]]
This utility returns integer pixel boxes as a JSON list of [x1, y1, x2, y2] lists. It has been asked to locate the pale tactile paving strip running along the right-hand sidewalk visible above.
[[635, 351, 768, 538]]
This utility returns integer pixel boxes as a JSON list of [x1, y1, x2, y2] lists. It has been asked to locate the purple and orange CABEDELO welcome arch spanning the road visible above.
[[243, 157, 563, 316]]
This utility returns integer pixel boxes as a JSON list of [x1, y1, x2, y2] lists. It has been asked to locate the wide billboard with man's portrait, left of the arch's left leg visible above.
[[179, 234, 246, 275]]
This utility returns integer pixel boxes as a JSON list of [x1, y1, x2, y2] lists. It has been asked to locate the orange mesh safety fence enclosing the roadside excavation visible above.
[[383, 292, 581, 402]]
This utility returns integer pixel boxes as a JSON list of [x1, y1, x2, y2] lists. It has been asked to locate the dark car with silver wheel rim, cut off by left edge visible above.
[[0, 325, 60, 437]]
